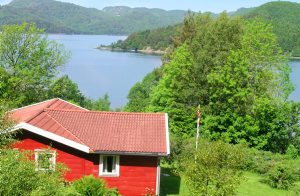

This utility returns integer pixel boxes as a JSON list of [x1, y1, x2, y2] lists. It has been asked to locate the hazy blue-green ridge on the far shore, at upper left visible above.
[[0, 0, 186, 35]]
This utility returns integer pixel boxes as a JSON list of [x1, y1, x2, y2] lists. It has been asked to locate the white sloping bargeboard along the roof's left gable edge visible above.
[[12, 122, 90, 153]]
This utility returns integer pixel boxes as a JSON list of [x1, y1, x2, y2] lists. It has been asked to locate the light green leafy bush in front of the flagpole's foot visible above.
[[181, 141, 245, 195]]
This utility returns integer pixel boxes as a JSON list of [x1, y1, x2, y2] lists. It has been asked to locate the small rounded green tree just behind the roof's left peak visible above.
[[48, 75, 85, 106]]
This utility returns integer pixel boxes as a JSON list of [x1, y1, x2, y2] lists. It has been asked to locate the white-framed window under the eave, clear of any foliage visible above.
[[99, 155, 120, 177]]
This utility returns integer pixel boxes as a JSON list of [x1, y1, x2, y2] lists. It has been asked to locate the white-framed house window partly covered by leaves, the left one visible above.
[[34, 149, 56, 171]]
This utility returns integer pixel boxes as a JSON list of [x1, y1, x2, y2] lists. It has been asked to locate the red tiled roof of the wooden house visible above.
[[12, 99, 169, 155]]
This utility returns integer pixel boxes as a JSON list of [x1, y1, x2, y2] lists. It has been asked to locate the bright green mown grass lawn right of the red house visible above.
[[160, 168, 300, 196]]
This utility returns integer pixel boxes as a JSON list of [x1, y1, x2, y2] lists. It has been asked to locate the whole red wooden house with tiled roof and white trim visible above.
[[11, 99, 170, 196]]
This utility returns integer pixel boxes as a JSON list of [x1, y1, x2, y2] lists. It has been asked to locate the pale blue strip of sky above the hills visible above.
[[0, 0, 300, 13]]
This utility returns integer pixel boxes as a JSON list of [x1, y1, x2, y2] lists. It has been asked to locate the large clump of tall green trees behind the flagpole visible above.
[[142, 13, 300, 153]]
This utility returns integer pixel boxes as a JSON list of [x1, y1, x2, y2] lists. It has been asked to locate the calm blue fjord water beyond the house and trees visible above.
[[49, 34, 300, 108]]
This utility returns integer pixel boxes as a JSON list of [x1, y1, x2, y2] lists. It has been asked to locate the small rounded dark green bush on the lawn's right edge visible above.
[[267, 164, 296, 190]]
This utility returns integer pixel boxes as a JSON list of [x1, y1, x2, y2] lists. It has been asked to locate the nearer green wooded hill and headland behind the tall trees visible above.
[[114, 1, 300, 56]]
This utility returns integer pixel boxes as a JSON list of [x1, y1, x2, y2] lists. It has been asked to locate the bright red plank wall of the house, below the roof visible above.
[[14, 131, 157, 196]]
